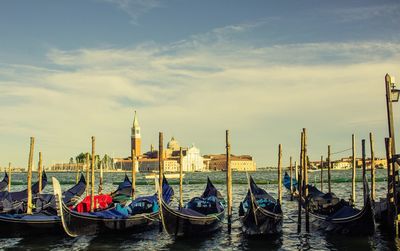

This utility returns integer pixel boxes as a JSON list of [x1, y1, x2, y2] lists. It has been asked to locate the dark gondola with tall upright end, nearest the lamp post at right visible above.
[[308, 178, 375, 235]]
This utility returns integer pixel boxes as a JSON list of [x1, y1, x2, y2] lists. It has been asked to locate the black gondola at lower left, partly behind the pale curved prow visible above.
[[0, 175, 86, 237]]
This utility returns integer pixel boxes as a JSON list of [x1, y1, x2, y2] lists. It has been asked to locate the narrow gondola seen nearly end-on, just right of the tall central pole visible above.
[[239, 176, 283, 236]]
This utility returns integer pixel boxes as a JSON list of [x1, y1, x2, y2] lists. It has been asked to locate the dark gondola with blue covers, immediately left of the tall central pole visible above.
[[159, 178, 225, 237]]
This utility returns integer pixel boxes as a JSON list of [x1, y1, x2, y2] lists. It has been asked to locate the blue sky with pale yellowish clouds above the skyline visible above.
[[0, 0, 400, 167]]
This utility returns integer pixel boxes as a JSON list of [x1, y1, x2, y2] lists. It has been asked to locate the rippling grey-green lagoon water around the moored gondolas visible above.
[[0, 170, 400, 250]]
